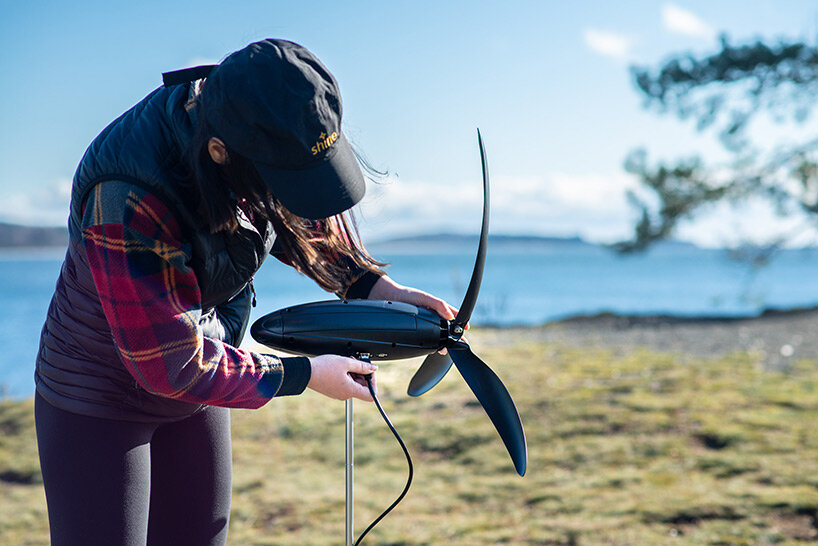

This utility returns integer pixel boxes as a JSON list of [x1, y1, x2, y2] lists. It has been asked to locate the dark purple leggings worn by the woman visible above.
[[34, 395, 232, 546]]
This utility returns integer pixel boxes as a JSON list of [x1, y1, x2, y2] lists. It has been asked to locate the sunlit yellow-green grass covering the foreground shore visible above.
[[0, 330, 818, 545]]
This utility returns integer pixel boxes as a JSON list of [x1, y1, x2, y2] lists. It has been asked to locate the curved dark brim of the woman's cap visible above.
[[254, 133, 366, 220]]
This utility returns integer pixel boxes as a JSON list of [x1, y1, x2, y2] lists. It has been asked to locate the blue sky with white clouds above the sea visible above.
[[0, 0, 818, 245]]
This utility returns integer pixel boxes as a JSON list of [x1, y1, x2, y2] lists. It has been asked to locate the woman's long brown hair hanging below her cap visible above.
[[188, 109, 386, 294]]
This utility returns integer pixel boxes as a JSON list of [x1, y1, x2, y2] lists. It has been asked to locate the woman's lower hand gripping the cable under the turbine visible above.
[[307, 355, 378, 402]]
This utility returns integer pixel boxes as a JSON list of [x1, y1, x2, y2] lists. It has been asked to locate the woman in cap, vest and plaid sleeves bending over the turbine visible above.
[[35, 40, 454, 545]]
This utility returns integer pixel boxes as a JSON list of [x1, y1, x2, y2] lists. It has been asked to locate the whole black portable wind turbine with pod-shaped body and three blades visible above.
[[250, 131, 528, 476]]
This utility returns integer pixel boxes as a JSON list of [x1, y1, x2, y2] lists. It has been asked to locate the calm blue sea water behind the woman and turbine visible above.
[[0, 242, 818, 397]]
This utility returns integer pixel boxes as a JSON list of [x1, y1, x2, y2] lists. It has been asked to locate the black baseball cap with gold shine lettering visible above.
[[200, 39, 366, 219]]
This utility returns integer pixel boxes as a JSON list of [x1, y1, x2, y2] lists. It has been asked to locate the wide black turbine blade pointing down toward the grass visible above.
[[449, 343, 528, 476]]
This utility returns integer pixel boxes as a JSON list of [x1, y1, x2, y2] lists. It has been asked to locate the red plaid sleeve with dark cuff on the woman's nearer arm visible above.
[[83, 182, 303, 408]]
